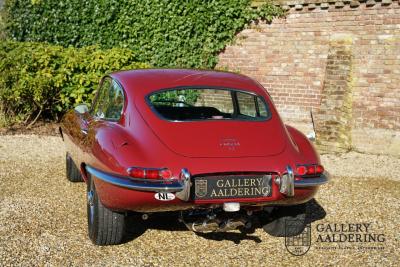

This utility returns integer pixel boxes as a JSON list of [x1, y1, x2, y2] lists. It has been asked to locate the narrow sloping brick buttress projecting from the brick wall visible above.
[[315, 38, 354, 152]]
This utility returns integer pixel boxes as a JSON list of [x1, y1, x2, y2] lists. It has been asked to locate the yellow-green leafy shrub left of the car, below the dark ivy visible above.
[[0, 41, 148, 121]]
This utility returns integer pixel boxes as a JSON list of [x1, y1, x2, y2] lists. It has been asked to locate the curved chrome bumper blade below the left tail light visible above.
[[86, 165, 184, 193]]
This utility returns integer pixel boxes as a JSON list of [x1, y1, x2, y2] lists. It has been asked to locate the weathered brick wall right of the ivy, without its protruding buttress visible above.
[[218, 0, 400, 154]]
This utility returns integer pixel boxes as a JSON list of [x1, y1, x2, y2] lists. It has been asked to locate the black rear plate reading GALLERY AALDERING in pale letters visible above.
[[194, 175, 272, 200]]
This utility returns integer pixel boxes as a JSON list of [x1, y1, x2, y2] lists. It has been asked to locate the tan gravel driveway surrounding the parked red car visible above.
[[0, 135, 400, 266]]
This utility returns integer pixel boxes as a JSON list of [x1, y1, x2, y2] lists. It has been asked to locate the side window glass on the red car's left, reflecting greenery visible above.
[[93, 78, 124, 121]]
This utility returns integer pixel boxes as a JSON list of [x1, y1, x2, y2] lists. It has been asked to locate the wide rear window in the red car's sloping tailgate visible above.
[[147, 88, 270, 121]]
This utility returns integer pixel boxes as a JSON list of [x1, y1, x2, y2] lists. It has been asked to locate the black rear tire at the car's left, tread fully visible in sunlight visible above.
[[87, 177, 125, 246]]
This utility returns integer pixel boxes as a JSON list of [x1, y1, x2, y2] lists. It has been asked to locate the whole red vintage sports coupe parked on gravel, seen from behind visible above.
[[60, 69, 328, 245]]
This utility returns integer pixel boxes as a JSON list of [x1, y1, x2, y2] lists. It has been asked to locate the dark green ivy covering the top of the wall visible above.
[[6, 0, 283, 68]]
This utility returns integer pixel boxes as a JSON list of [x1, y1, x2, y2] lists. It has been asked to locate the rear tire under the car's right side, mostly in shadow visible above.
[[263, 203, 307, 237]]
